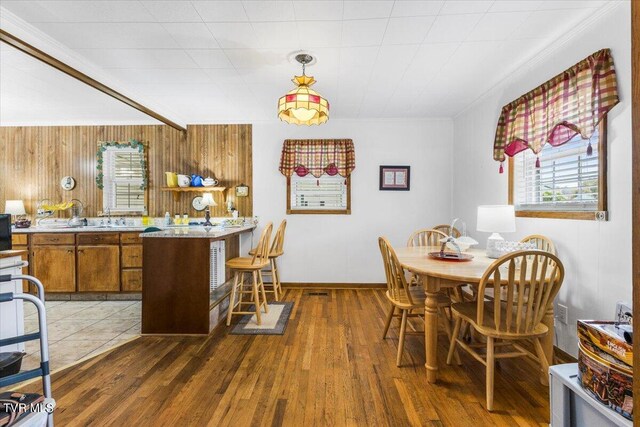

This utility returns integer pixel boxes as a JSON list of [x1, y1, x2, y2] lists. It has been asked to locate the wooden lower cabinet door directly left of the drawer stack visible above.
[[78, 245, 120, 292]]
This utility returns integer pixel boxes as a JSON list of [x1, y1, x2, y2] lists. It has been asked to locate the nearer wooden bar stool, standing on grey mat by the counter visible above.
[[227, 222, 273, 326]]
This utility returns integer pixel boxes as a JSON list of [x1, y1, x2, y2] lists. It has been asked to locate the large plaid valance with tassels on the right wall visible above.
[[493, 49, 618, 166]]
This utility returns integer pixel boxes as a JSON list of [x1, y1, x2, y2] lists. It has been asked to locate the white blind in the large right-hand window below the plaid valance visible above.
[[514, 131, 600, 211]]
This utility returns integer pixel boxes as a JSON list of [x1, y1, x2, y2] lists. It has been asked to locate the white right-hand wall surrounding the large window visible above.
[[452, 2, 631, 356]]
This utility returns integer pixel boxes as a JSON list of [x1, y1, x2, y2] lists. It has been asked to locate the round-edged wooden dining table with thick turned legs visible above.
[[394, 246, 554, 383]]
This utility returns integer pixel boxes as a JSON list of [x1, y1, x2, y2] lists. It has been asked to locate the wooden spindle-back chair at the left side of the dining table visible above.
[[378, 237, 457, 366]]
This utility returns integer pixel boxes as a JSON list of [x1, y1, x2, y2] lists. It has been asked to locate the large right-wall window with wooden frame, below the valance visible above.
[[509, 119, 607, 219]]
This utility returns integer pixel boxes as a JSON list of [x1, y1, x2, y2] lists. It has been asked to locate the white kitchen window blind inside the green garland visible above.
[[103, 148, 145, 212]]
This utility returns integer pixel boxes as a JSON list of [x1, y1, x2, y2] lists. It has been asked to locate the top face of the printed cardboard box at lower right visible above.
[[578, 320, 633, 370]]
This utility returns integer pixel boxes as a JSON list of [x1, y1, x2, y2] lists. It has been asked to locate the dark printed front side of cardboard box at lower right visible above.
[[578, 343, 633, 420]]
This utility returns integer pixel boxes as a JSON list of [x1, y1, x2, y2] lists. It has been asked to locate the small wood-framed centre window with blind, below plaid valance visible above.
[[287, 174, 351, 215]]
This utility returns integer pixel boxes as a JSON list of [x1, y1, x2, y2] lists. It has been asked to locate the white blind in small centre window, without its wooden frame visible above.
[[291, 174, 347, 210]]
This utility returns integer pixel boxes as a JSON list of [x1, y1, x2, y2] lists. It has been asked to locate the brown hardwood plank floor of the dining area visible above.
[[20, 289, 549, 427]]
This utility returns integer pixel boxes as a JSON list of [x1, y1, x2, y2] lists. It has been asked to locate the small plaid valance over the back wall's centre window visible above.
[[280, 139, 356, 178]]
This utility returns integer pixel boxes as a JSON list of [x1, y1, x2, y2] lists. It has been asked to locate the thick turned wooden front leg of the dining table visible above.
[[423, 277, 440, 383]]
